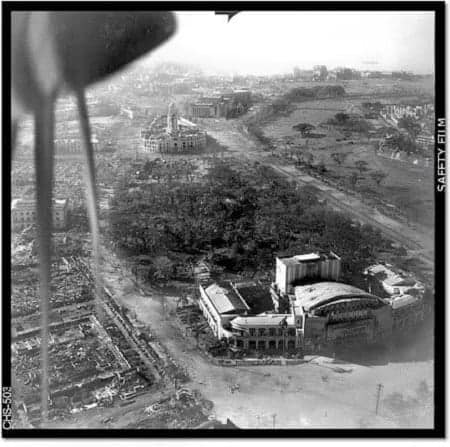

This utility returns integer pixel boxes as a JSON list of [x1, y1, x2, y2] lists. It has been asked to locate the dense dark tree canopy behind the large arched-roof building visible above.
[[110, 160, 394, 276]]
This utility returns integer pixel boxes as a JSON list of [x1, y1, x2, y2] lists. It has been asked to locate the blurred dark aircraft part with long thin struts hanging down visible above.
[[11, 11, 176, 427]]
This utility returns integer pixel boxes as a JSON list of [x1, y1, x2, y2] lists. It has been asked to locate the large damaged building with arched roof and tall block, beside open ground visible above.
[[199, 252, 421, 353]]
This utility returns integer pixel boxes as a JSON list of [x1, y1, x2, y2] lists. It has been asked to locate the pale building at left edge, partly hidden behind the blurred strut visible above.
[[11, 199, 69, 231]]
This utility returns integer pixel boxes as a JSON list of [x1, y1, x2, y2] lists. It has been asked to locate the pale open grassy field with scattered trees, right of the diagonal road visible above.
[[263, 98, 434, 228]]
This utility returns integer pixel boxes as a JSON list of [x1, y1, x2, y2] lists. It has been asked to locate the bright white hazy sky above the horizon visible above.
[[144, 11, 434, 75]]
